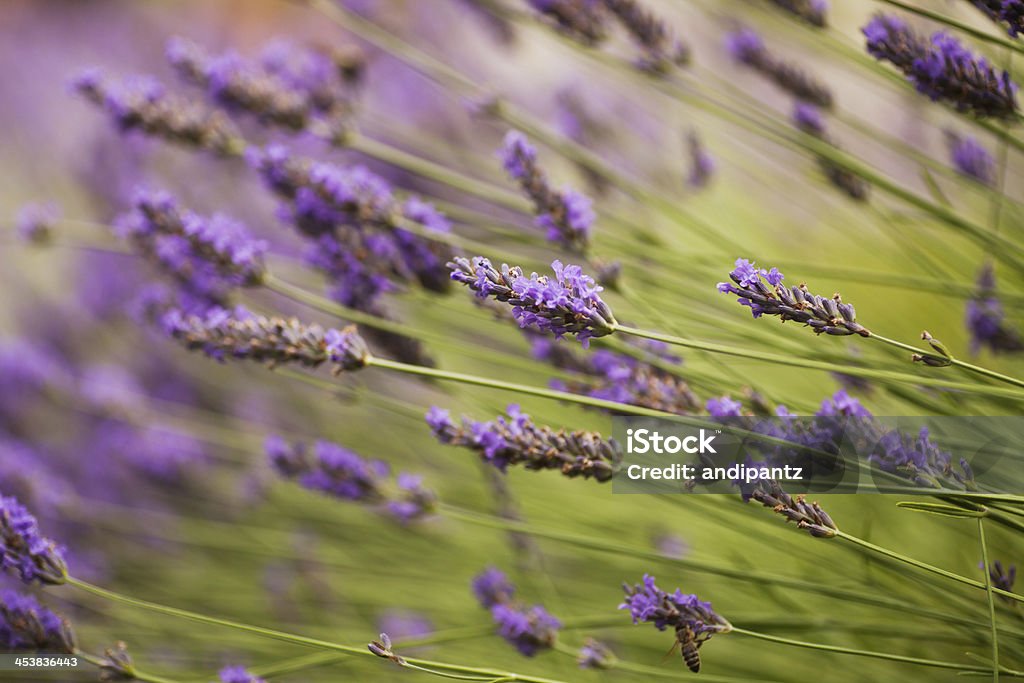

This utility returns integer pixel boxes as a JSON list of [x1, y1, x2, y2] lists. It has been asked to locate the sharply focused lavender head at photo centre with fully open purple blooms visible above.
[[449, 256, 615, 347]]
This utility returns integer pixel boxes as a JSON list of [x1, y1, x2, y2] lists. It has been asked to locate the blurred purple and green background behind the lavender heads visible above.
[[0, 0, 1024, 682]]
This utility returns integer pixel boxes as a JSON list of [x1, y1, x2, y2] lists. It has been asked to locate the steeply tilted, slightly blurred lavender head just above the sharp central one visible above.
[[502, 130, 595, 251]]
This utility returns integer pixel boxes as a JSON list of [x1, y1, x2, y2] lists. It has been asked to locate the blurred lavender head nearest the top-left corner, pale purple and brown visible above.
[[72, 70, 245, 156]]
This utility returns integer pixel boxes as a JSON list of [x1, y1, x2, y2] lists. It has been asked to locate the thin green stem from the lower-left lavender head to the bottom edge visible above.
[[67, 577, 563, 683]]
